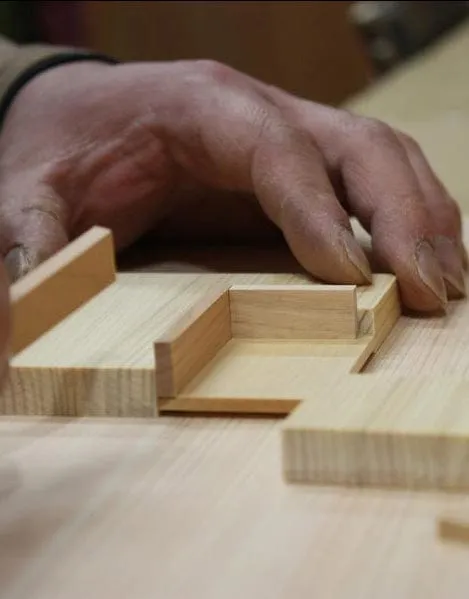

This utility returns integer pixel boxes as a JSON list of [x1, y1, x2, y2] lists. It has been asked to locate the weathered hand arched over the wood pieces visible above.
[[0, 61, 465, 311]]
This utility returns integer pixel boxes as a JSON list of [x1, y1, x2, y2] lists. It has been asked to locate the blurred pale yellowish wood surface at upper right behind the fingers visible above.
[[346, 22, 469, 212]]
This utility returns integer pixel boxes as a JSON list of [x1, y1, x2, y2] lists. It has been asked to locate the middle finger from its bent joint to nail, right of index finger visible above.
[[334, 121, 447, 312]]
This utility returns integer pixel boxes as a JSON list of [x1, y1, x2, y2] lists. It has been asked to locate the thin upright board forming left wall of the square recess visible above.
[[154, 289, 231, 398]]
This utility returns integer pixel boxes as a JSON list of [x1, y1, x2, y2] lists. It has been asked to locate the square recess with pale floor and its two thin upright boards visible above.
[[155, 275, 400, 415]]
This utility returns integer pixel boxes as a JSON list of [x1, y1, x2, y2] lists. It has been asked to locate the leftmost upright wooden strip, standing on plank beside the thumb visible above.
[[10, 227, 116, 354]]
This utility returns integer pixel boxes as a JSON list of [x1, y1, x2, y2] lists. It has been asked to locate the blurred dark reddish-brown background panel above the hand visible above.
[[80, 0, 373, 104]]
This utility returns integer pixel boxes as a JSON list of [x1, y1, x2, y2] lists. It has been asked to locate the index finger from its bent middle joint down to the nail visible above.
[[251, 123, 371, 285]]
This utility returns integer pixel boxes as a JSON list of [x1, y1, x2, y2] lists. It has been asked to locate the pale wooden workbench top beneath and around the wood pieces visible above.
[[4, 22, 469, 599]]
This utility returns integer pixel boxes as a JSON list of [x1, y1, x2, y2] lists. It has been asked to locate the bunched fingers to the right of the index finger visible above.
[[250, 86, 462, 311]]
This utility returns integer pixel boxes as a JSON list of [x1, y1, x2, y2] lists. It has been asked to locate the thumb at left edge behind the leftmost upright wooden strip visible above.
[[0, 188, 69, 282]]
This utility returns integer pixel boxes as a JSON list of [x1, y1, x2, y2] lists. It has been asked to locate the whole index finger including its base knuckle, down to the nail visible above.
[[171, 66, 371, 285]]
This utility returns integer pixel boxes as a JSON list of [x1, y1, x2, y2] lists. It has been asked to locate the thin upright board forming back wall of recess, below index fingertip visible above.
[[229, 285, 358, 339]]
